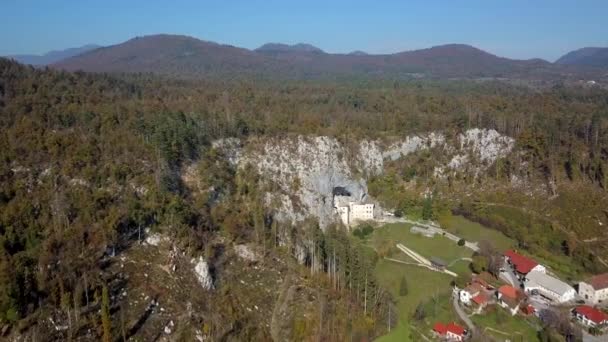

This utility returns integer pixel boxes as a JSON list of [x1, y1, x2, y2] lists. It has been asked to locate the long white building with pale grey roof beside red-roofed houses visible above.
[[524, 271, 576, 303]]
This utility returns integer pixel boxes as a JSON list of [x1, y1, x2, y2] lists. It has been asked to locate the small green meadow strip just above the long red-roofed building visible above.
[[441, 216, 517, 251]]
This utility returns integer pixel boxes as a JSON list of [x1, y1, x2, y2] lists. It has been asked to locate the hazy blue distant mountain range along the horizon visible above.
[[39, 34, 608, 81]]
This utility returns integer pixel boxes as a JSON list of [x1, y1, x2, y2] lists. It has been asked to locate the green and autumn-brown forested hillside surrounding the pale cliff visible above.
[[0, 58, 608, 341]]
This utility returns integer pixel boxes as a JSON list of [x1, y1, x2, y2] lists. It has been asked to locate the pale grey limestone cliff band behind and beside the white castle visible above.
[[213, 129, 514, 228]]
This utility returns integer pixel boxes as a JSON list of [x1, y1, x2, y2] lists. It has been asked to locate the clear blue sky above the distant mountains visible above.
[[0, 0, 608, 61]]
